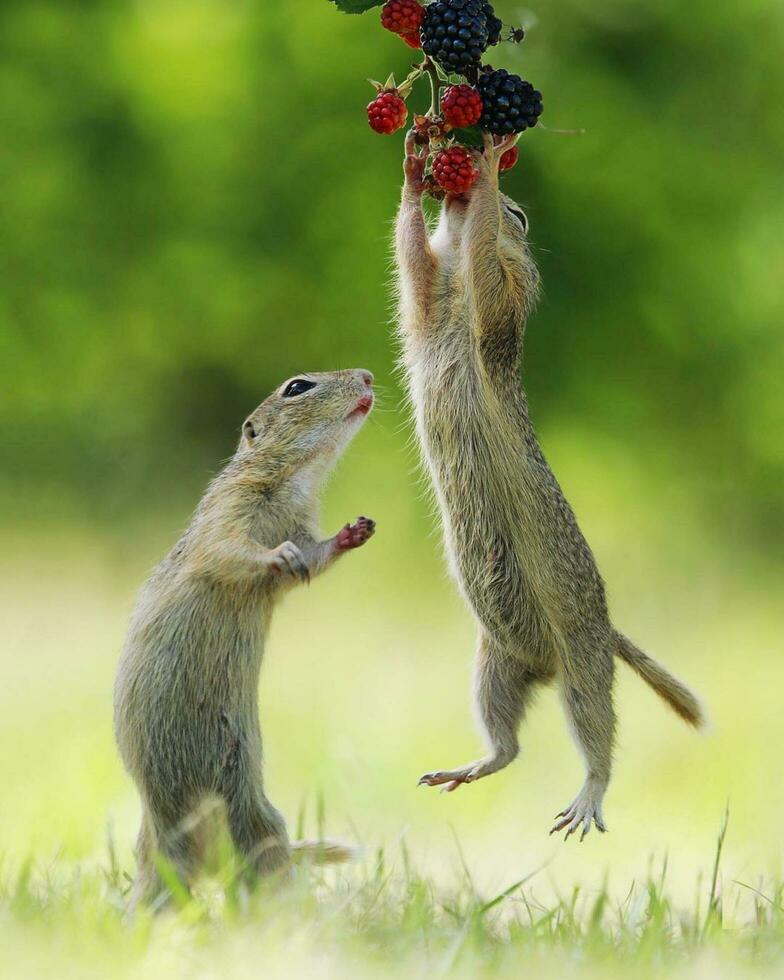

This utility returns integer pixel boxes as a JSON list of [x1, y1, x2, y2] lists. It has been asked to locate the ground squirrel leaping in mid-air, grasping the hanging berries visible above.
[[396, 134, 703, 839]]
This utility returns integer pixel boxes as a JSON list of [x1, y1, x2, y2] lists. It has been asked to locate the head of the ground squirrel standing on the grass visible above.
[[237, 368, 373, 472]]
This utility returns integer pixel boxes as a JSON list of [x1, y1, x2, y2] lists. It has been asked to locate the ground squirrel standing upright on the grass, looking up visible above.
[[114, 370, 375, 907]]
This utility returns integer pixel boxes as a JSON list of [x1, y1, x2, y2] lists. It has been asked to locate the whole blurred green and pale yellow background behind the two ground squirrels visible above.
[[0, 0, 784, 920]]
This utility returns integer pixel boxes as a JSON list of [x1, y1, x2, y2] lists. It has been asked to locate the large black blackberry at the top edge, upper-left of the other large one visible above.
[[422, 0, 488, 75]]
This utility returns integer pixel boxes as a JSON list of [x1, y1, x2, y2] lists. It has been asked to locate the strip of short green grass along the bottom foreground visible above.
[[0, 812, 784, 980]]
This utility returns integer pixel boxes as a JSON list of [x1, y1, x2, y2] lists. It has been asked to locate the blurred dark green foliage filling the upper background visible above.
[[0, 0, 784, 543]]
